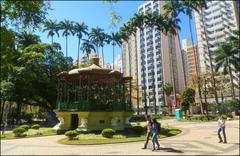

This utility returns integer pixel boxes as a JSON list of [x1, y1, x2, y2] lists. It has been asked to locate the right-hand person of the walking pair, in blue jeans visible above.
[[152, 118, 160, 151]]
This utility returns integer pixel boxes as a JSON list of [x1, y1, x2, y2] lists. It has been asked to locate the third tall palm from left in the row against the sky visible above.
[[74, 23, 88, 65]]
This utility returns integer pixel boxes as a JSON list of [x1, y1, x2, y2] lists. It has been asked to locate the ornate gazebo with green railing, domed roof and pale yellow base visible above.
[[54, 58, 132, 131]]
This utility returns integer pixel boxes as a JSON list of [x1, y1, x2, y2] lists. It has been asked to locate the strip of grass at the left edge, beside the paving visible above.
[[0, 128, 56, 139]]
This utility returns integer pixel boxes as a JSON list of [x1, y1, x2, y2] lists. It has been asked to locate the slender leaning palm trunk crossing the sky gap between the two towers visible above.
[[188, 15, 203, 114]]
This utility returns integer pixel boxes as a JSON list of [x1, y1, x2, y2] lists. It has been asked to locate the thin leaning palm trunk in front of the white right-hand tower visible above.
[[201, 9, 219, 104]]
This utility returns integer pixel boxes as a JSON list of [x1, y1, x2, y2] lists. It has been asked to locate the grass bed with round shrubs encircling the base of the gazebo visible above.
[[58, 126, 181, 145]]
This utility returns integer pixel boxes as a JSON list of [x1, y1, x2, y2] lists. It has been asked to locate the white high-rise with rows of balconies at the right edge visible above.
[[194, 0, 239, 94]]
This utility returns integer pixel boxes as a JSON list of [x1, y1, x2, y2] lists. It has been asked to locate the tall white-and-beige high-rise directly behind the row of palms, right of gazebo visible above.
[[122, 1, 184, 112]]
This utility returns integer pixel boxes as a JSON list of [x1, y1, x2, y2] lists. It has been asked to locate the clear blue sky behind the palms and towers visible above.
[[38, 1, 195, 63]]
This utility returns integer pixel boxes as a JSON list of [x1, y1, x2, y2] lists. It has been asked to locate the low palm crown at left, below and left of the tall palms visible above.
[[17, 31, 41, 50]]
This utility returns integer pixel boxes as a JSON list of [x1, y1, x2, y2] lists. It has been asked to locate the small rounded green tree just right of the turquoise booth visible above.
[[181, 88, 195, 115]]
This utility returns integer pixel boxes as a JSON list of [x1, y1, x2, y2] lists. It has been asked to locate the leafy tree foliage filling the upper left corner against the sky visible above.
[[1, 0, 50, 29]]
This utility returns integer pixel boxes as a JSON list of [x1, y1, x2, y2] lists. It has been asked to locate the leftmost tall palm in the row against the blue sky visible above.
[[43, 20, 59, 44]]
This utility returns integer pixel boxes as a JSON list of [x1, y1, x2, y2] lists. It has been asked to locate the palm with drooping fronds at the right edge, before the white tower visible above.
[[214, 43, 240, 99]]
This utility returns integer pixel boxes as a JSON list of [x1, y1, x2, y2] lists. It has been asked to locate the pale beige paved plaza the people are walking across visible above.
[[1, 120, 239, 155]]
